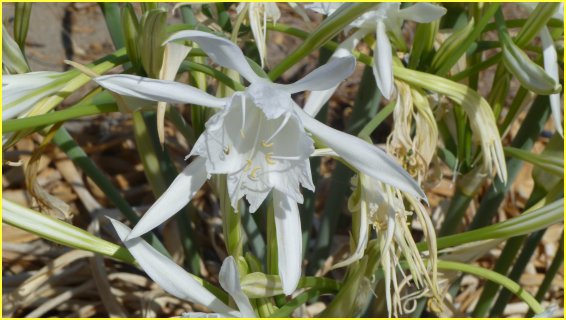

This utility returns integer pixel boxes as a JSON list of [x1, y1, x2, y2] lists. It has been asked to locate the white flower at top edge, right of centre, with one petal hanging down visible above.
[[308, 2, 446, 99]]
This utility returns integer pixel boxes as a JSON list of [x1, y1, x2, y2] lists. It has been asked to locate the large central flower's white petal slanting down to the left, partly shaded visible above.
[[128, 157, 207, 239]]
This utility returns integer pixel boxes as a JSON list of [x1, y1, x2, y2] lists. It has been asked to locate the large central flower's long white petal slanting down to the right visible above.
[[296, 108, 426, 200]]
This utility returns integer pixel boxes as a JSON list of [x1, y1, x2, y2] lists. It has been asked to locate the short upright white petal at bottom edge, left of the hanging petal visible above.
[[218, 256, 257, 318]]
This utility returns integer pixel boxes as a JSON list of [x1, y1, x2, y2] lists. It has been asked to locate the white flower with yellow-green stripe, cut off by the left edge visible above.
[[2, 71, 66, 120]]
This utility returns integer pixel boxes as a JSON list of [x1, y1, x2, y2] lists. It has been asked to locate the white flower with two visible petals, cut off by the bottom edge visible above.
[[109, 218, 257, 318]]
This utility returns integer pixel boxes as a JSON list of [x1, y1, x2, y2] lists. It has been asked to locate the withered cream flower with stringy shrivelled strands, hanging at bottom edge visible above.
[[342, 174, 442, 317]]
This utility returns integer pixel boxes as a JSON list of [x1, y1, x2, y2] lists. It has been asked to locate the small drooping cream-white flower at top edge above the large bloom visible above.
[[236, 2, 281, 68]]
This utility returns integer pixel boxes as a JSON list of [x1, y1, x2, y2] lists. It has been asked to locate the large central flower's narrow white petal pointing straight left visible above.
[[94, 74, 227, 108]]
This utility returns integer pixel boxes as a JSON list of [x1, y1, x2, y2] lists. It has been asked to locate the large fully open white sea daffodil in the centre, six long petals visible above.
[[95, 30, 425, 294]]
